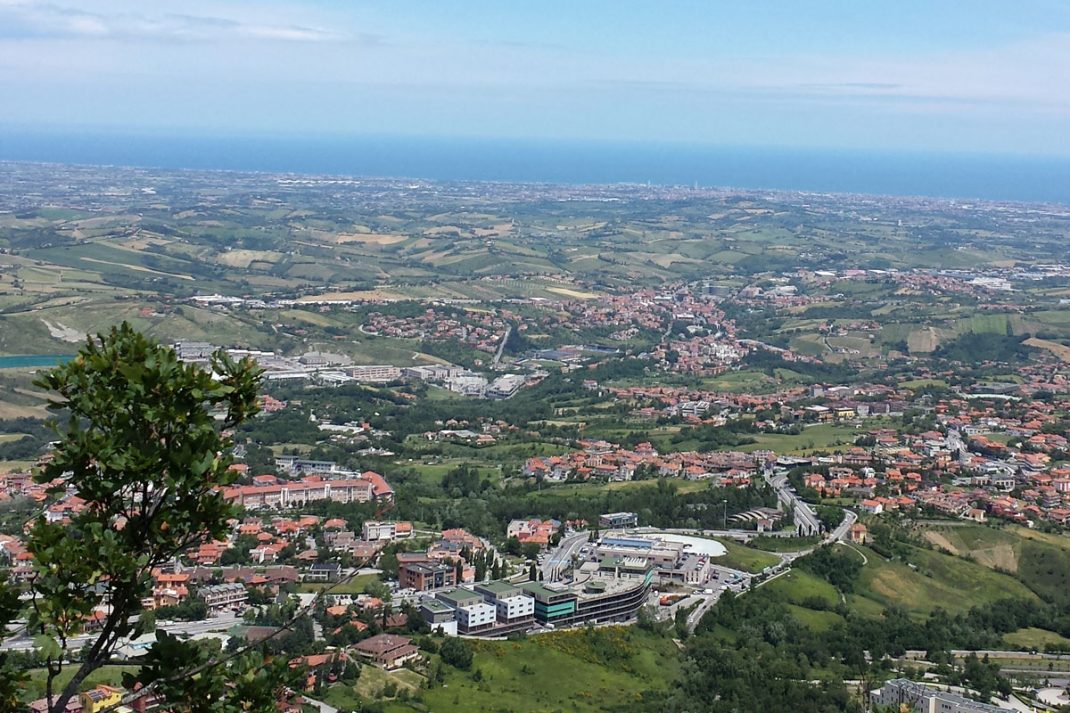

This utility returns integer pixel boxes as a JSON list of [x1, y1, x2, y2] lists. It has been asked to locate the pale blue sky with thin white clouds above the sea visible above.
[[0, 0, 1070, 157]]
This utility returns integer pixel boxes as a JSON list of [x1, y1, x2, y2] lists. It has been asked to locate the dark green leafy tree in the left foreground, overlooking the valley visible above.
[[9, 322, 293, 711]]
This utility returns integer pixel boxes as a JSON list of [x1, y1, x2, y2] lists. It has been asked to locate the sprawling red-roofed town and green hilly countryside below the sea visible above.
[[0, 165, 1070, 713]]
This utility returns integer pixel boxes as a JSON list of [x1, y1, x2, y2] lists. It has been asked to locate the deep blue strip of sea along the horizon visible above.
[[0, 127, 1070, 204]]
